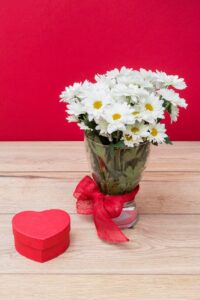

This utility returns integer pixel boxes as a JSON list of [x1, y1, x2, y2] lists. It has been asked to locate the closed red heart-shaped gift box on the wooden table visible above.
[[12, 209, 70, 262]]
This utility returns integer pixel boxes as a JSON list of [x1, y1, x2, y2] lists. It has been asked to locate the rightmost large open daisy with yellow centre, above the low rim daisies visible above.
[[139, 93, 164, 123]]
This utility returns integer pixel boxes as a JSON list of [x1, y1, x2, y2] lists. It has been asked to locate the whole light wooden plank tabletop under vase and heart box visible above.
[[0, 142, 200, 300]]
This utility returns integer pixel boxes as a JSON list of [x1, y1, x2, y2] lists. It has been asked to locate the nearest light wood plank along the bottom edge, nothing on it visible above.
[[0, 274, 200, 300]]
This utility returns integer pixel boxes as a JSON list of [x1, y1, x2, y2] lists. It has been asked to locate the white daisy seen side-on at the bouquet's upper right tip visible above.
[[156, 71, 187, 90]]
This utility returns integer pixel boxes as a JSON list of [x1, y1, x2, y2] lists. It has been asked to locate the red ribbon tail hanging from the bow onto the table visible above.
[[93, 200, 129, 243]]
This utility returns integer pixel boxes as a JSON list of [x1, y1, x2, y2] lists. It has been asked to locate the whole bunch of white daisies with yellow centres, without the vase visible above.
[[60, 67, 187, 147]]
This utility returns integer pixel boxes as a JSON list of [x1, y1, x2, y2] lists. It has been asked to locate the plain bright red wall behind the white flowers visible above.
[[0, 0, 200, 140]]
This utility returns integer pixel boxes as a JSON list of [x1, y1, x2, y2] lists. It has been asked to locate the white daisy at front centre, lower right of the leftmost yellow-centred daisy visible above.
[[102, 103, 133, 134]]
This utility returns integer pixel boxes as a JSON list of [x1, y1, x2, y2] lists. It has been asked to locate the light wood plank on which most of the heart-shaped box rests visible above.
[[0, 215, 200, 275]]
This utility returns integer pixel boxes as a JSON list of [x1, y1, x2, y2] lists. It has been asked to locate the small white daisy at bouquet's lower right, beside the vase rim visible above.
[[147, 123, 167, 144]]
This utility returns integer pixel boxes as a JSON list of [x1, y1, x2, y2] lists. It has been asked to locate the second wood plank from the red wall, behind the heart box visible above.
[[0, 172, 200, 214]]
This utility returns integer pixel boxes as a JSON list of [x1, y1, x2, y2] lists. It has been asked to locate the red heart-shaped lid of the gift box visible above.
[[12, 209, 70, 250]]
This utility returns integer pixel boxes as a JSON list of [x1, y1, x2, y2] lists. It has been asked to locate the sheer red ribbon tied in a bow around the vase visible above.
[[74, 176, 139, 243]]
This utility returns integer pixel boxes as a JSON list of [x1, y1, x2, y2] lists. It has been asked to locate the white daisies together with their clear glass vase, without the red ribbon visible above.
[[60, 67, 187, 243]]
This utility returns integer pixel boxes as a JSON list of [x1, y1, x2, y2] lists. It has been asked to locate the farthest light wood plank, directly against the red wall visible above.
[[0, 142, 200, 172]]
